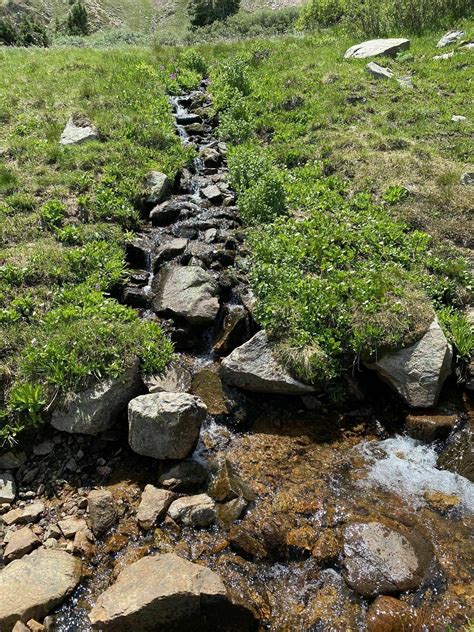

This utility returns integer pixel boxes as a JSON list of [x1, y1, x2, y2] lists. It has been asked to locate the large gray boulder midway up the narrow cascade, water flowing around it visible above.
[[153, 266, 219, 327]]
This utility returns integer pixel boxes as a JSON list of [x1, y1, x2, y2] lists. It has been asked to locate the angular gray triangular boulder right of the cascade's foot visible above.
[[220, 331, 315, 395]]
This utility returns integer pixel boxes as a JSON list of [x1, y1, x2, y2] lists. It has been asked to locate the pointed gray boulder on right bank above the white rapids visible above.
[[367, 318, 453, 408]]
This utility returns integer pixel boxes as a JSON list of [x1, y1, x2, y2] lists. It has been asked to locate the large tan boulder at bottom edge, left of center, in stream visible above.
[[89, 553, 257, 632]]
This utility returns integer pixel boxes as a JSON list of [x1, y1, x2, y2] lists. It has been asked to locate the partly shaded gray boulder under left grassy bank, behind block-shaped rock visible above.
[[51, 360, 142, 435]]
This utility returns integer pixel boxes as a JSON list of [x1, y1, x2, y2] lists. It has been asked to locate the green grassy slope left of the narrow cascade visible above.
[[0, 49, 208, 439]]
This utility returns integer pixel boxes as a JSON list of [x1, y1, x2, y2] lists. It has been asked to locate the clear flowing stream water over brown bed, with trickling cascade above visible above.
[[47, 86, 474, 632]]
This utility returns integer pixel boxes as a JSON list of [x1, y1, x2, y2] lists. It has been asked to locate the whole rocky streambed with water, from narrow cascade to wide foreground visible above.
[[0, 84, 474, 632]]
